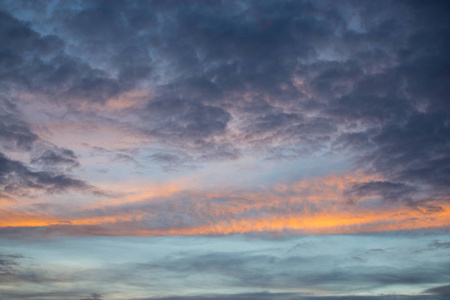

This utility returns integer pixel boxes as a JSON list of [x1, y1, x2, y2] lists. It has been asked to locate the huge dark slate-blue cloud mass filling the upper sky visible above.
[[0, 1, 450, 216]]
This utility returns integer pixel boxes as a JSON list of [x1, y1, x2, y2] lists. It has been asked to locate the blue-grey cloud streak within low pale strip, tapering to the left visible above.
[[136, 252, 450, 291]]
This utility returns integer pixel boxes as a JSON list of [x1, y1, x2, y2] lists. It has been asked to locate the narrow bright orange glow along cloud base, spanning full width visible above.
[[0, 199, 450, 235]]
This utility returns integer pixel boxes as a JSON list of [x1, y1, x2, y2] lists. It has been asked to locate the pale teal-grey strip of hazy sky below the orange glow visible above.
[[0, 233, 450, 300]]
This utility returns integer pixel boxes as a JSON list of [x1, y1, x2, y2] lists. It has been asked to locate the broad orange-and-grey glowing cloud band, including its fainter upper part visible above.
[[0, 174, 450, 236]]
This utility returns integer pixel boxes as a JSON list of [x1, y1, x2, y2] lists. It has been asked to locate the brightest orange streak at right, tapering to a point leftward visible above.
[[148, 206, 450, 235]]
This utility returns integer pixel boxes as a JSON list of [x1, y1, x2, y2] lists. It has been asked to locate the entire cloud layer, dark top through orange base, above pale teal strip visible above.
[[0, 1, 450, 235]]
